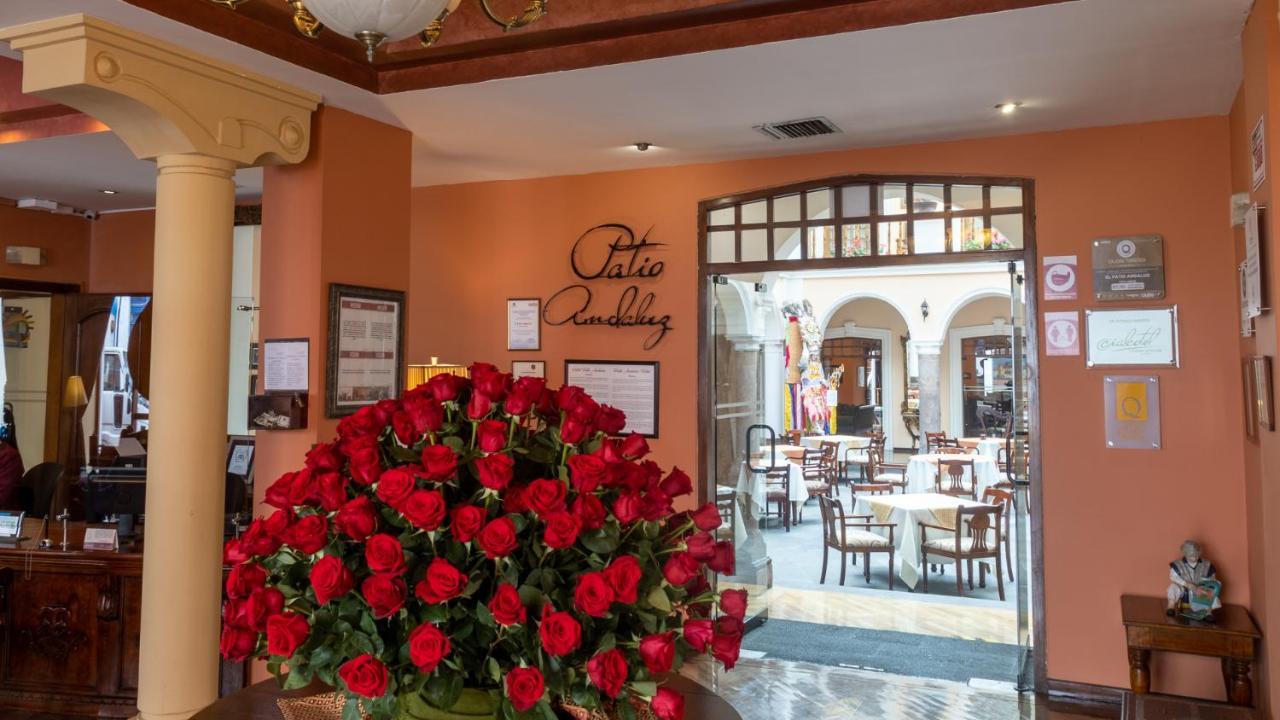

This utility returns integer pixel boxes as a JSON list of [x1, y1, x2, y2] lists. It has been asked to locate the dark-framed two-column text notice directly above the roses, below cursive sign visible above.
[[564, 360, 658, 438]]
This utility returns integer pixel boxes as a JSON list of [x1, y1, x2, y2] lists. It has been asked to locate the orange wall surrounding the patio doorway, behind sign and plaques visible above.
[[408, 118, 1251, 698]]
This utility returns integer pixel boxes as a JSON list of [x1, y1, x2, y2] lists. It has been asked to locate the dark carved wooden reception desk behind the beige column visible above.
[[0, 520, 244, 717]]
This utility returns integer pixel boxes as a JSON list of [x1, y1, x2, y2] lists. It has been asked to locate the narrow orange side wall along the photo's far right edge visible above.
[[1230, 0, 1280, 716]]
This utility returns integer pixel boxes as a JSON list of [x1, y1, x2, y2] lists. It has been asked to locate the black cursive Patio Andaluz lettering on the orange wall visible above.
[[543, 223, 671, 350]]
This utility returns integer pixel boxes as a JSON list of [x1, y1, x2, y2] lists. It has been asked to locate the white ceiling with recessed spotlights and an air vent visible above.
[[0, 0, 1252, 209]]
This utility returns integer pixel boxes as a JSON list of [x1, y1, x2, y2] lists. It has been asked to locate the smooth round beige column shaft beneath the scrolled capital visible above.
[[138, 155, 236, 720]]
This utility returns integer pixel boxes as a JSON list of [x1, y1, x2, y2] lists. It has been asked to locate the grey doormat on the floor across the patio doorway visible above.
[[742, 620, 1021, 683]]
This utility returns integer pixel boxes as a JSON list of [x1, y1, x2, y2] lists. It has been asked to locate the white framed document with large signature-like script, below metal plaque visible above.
[[1084, 305, 1179, 368]]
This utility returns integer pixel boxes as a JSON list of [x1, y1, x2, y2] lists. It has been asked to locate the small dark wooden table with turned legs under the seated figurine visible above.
[[1120, 594, 1262, 706]]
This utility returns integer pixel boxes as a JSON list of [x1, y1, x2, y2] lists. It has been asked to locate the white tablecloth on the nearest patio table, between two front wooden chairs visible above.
[[852, 492, 980, 589]]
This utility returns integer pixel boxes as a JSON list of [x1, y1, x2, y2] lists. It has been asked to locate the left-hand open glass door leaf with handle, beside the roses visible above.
[[707, 275, 762, 628]]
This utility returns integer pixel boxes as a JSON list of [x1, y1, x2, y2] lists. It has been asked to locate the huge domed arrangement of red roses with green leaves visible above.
[[220, 364, 746, 720]]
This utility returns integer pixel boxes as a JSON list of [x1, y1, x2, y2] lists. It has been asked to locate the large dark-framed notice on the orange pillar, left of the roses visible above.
[[325, 283, 404, 418]]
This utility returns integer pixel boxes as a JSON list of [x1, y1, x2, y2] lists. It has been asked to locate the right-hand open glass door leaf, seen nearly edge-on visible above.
[[1002, 263, 1036, 691]]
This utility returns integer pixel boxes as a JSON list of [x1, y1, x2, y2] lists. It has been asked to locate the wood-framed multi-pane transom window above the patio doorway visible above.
[[701, 177, 1029, 266]]
